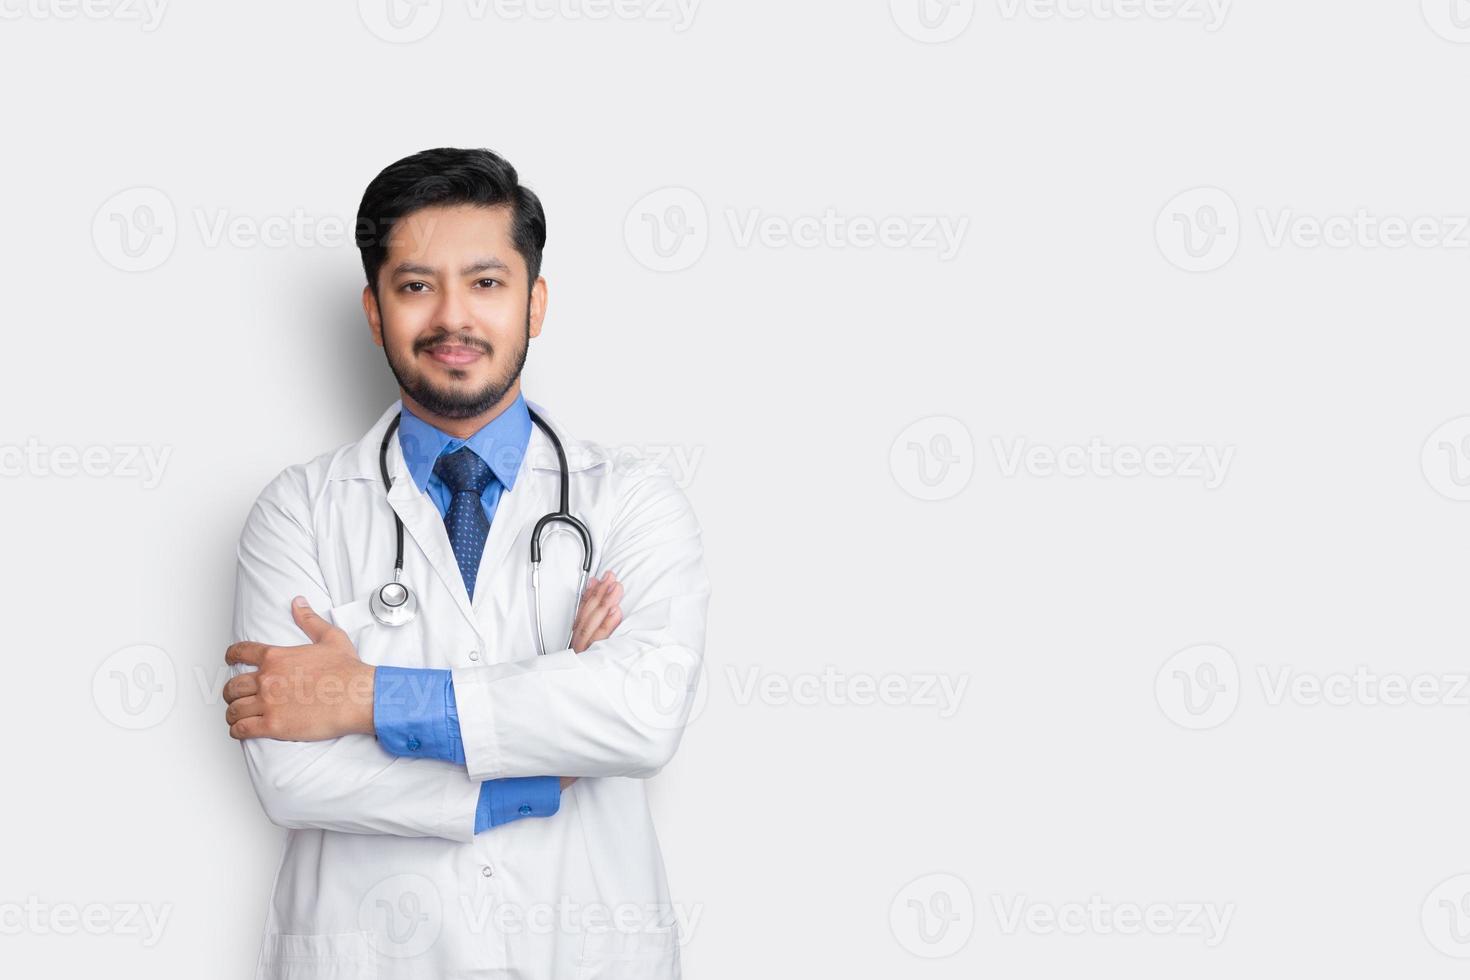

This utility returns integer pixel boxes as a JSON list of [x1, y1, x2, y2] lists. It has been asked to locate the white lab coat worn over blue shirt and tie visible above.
[[232, 401, 709, 980]]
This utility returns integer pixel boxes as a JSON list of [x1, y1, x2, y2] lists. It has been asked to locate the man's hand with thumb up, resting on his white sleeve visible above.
[[223, 597, 375, 742]]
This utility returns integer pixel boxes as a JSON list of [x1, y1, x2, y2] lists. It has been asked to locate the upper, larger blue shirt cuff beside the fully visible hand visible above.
[[372, 667, 465, 765]]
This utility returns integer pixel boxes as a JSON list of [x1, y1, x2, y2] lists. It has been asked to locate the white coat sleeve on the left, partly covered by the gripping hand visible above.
[[231, 467, 482, 842]]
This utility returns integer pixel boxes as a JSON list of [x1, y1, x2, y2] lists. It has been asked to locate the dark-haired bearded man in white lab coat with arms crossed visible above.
[[223, 148, 710, 980]]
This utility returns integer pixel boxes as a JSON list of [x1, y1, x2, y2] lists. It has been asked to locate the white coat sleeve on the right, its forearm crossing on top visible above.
[[453, 470, 710, 779]]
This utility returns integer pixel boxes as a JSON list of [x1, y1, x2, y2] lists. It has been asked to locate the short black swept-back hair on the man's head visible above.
[[356, 147, 547, 297]]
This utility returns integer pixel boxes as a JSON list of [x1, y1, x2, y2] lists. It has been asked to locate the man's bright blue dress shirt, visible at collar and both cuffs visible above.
[[372, 395, 562, 833]]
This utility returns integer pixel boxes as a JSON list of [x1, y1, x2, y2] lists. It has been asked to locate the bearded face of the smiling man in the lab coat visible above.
[[363, 204, 547, 422]]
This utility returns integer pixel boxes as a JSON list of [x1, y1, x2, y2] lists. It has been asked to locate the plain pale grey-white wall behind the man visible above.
[[0, 0, 1470, 980]]
